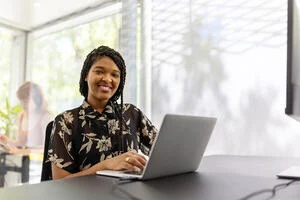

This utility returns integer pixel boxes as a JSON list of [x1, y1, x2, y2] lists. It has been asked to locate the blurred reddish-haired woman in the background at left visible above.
[[0, 81, 52, 151]]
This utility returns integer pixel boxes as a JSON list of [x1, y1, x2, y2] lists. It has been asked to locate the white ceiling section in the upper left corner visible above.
[[0, 0, 103, 30]]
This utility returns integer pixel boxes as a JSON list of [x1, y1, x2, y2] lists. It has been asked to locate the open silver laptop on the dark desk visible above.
[[97, 114, 217, 180]]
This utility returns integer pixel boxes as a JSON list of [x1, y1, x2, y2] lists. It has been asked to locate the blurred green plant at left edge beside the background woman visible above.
[[0, 98, 22, 137]]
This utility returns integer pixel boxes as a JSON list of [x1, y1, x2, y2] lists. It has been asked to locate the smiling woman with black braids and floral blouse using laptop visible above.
[[48, 46, 157, 179]]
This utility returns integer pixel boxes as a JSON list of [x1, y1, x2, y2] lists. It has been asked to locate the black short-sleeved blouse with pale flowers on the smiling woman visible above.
[[48, 101, 157, 173]]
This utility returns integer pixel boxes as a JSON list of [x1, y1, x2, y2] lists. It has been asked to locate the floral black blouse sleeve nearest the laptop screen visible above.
[[138, 110, 158, 155]]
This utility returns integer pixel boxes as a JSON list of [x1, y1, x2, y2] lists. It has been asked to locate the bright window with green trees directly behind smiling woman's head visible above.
[[30, 14, 121, 115]]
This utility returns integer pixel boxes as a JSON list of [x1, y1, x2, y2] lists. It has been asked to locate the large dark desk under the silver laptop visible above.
[[0, 156, 300, 200]]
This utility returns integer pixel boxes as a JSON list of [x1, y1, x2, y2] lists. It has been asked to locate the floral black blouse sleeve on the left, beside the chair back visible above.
[[48, 111, 76, 173]]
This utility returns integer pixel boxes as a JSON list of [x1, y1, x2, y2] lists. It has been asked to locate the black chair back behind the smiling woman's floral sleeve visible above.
[[41, 121, 53, 181]]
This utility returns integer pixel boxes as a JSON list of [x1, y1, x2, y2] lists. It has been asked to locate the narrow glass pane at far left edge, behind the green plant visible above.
[[0, 26, 25, 137]]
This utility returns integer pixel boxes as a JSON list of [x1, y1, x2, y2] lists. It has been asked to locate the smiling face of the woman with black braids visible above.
[[85, 56, 121, 105]]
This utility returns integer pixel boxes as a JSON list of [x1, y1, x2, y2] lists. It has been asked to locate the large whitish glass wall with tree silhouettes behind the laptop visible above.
[[152, 0, 300, 156]]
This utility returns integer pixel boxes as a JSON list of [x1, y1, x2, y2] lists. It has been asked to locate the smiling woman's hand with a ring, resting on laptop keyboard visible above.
[[101, 151, 147, 171]]
